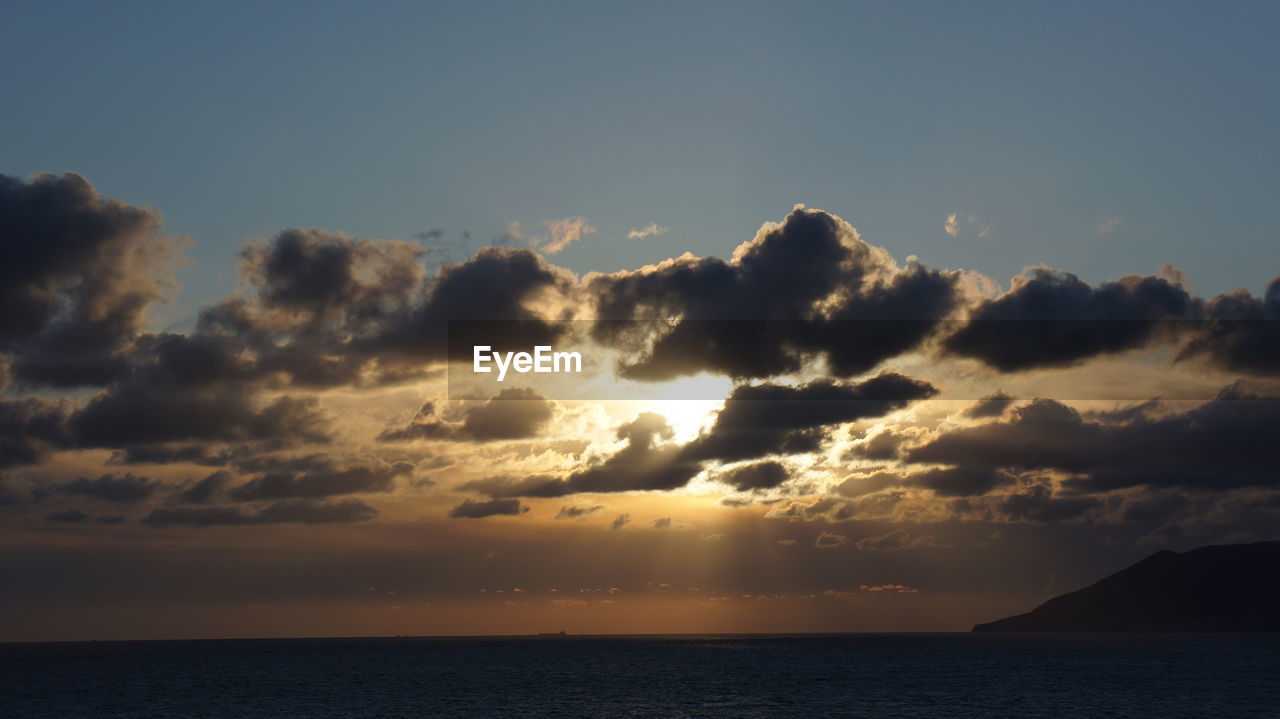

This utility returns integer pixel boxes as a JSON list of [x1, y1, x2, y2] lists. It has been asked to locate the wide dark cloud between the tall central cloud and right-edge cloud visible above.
[[943, 269, 1198, 372]]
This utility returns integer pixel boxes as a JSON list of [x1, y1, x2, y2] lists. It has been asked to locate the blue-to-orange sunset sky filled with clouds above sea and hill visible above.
[[0, 1, 1280, 641]]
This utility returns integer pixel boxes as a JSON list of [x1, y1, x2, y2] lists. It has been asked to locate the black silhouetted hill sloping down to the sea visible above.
[[973, 541, 1280, 632]]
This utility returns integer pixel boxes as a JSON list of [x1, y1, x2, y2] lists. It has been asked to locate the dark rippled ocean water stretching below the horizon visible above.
[[0, 635, 1280, 719]]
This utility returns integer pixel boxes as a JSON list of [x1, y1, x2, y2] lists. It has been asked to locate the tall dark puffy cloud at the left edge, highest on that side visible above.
[[0, 173, 177, 386]]
